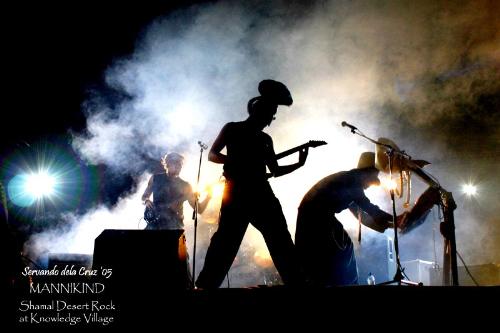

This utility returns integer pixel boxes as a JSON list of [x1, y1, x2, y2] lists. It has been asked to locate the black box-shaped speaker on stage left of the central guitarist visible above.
[[92, 230, 191, 292]]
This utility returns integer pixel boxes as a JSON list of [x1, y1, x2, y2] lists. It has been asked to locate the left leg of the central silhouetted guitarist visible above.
[[196, 207, 248, 289]]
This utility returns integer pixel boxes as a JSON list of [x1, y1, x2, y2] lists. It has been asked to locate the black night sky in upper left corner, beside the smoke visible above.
[[1, 1, 204, 148]]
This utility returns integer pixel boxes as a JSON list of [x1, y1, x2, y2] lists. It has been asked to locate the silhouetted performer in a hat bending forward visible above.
[[295, 152, 392, 287]]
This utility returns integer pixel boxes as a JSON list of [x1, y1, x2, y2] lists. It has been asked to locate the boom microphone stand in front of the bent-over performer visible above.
[[342, 126, 422, 286]]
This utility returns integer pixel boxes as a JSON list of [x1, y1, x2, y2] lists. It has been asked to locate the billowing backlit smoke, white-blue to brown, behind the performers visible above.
[[28, 0, 500, 286]]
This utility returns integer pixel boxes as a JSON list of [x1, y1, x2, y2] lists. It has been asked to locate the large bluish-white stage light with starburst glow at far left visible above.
[[2, 141, 94, 215]]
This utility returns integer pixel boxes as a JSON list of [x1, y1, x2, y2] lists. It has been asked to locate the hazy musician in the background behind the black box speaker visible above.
[[142, 153, 211, 230]]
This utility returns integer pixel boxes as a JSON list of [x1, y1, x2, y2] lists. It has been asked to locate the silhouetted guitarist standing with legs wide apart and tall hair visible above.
[[196, 80, 308, 288]]
